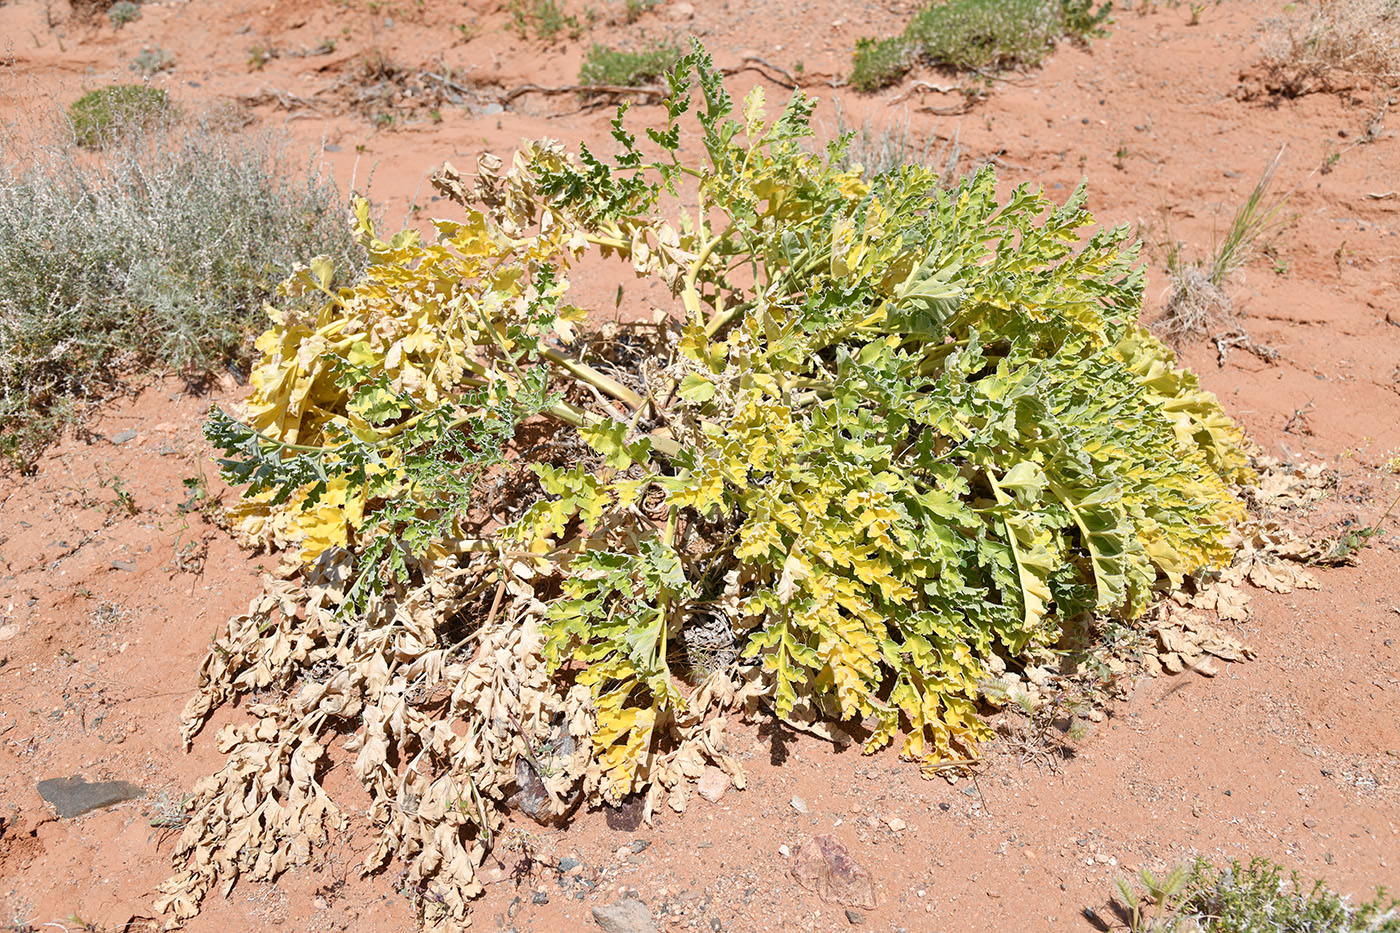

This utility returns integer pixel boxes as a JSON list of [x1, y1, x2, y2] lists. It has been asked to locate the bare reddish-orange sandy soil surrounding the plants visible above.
[[0, 0, 1400, 930]]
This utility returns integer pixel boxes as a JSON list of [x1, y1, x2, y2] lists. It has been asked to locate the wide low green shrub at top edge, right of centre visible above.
[[850, 0, 1110, 91]]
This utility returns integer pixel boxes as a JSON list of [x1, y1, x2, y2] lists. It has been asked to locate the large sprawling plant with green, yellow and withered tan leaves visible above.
[[169, 46, 1249, 923]]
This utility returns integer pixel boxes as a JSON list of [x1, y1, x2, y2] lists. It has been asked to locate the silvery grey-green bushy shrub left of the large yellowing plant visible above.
[[0, 116, 363, 465]]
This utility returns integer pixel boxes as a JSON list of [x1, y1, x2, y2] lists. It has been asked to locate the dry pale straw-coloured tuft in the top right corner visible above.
[[1260, 0, 1400, 97]]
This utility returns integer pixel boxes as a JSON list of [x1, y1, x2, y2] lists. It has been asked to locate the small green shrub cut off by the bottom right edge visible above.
[[1114, 859, 1400, 933]]
